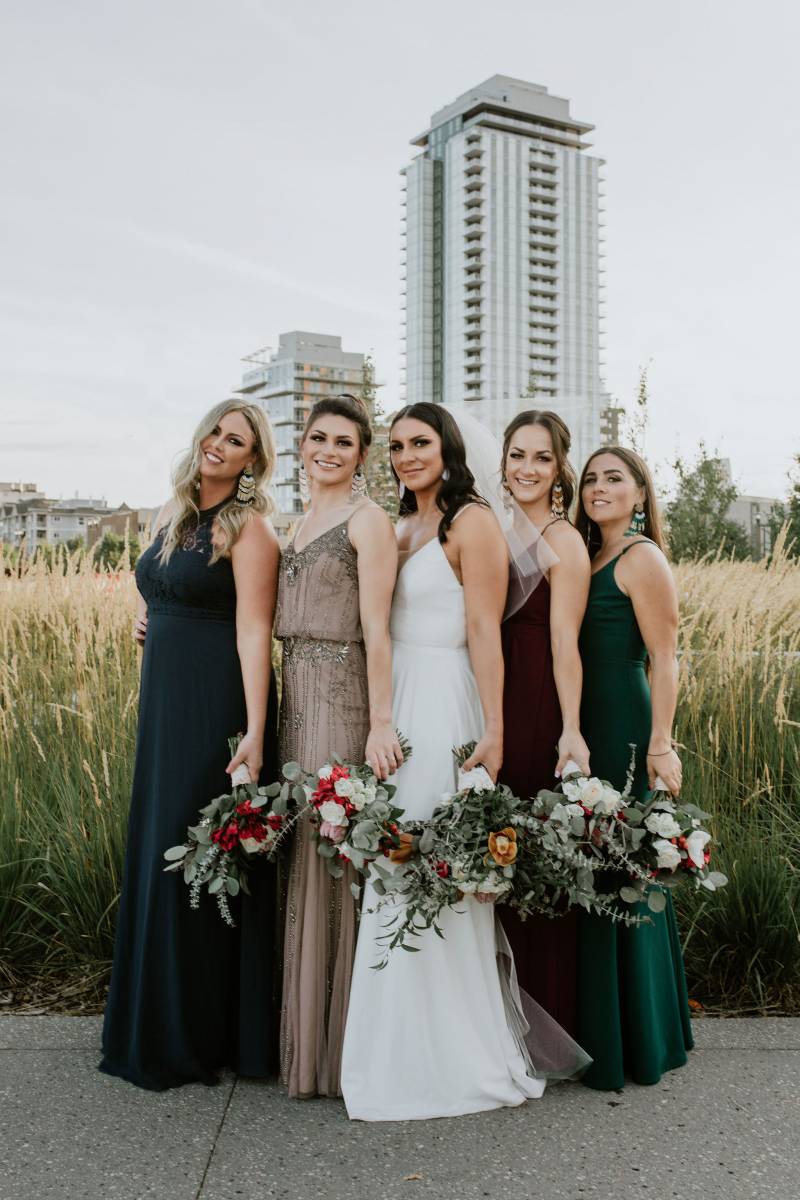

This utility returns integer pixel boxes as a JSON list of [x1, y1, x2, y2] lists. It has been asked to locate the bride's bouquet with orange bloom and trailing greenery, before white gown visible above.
[[372, 742, 522, 970]]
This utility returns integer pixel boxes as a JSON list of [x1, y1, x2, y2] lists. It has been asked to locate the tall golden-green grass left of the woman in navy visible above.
[[0, 556, 138, 977]]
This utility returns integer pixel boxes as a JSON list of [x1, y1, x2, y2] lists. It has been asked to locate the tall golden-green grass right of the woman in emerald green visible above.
[[675, 530, 800, 1012]]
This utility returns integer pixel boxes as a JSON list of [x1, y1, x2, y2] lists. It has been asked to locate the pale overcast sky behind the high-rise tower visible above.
[[0, 0, 800, 505]]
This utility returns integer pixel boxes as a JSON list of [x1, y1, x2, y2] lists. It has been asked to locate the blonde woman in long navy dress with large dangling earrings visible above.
[[101, 401, 279, 1091]]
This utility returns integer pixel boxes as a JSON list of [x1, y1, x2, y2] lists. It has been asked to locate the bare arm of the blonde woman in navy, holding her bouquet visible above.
[[225, 516, 281, 781]]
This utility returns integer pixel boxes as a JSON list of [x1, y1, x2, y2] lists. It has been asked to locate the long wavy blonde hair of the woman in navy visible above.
[[158, 400, 275, 565]]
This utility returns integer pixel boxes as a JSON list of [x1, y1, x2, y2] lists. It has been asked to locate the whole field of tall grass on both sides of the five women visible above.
[[0, 544, 800, 1013]]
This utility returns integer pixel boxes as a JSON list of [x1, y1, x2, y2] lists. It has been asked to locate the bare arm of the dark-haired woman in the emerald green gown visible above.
[[615, 542, 681, 796]]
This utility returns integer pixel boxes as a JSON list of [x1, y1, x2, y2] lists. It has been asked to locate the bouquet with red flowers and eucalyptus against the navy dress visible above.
[[164, 738, 288, 926]]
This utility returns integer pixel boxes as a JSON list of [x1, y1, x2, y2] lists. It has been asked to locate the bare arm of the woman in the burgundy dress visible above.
[[547, 521, 591, 775]]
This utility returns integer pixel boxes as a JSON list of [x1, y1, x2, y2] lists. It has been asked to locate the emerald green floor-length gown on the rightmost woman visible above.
[[576, 542, 693, 1091]]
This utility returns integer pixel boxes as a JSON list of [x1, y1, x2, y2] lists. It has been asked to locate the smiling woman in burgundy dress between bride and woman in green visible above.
[[500, 410, 590, 1036]]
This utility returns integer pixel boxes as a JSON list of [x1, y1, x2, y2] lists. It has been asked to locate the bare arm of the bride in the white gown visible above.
[[445, 504, 509, 780]]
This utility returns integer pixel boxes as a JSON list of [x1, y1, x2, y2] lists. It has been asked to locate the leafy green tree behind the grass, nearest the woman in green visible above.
[[664, 442, 751, 562]]
